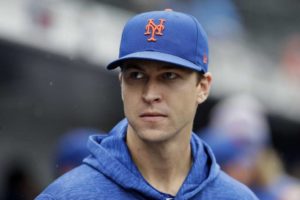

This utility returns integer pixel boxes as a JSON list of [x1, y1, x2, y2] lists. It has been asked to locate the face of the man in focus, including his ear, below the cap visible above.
[[120, 60, 211, 142]]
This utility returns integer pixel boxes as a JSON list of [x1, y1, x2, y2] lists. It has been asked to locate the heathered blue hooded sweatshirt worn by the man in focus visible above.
[[36, 119, 257, 200]]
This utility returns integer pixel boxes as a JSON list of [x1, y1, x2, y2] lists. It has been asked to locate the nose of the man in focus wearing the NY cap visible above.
[[142, 80, 161, 103]]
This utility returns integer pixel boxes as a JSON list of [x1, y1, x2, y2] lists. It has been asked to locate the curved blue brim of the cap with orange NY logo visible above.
[[107, 51, 206, 73]]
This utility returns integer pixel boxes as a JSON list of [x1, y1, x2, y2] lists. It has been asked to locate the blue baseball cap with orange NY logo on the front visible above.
[[107, 9, 208, 73]]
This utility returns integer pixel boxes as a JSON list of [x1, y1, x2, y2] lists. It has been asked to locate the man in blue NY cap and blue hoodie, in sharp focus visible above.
[[37, 10, 257, 200]]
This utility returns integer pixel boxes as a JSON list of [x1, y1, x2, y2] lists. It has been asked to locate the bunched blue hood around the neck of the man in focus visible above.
[[83, 119, 220, 199]]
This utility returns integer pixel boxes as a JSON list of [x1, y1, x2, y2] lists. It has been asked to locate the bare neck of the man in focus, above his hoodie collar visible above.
[[126, 128, 192, 195]]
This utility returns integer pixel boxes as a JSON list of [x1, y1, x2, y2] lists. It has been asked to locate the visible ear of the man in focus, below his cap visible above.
[[197, 72, 212, 104]]
